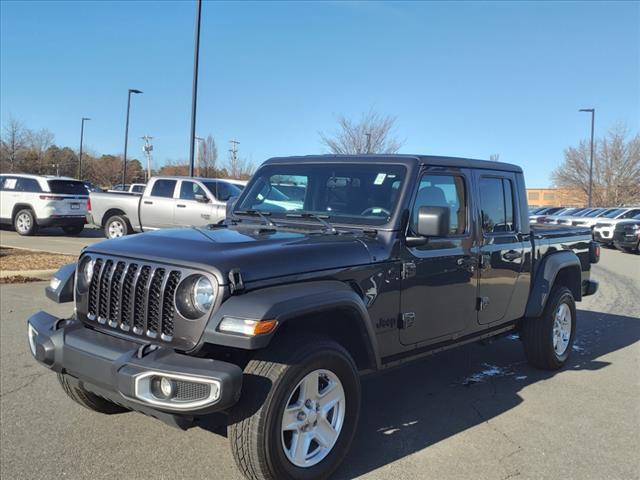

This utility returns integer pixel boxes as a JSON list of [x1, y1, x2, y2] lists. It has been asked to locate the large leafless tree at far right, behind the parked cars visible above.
[[552, 127, 640, 207]]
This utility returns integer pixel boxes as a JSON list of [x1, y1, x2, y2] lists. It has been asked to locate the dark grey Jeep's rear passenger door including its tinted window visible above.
[[475, 171, 524, 324]]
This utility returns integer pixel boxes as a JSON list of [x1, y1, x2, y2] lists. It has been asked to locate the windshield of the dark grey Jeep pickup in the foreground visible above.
[[234, 163, 406, 225]]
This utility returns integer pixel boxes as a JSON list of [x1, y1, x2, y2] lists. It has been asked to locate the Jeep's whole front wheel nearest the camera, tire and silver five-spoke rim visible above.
[[229, 338, 360, 480]]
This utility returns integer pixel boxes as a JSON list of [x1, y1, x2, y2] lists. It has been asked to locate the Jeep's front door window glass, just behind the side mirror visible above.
[[411, 175, 467, 235]]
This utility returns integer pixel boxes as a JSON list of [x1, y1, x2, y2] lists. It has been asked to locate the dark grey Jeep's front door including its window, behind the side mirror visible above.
[[400, 167, 477, 345]]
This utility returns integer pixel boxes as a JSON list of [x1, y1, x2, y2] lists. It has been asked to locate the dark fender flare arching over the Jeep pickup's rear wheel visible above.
[[525, 250, 582, 317]]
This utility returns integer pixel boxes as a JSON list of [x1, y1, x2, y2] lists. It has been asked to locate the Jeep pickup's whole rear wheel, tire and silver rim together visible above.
[[522, 286, 576, 370]]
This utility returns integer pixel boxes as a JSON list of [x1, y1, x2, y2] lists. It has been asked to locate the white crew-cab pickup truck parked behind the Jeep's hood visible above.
[[89, 177, 242, 238]]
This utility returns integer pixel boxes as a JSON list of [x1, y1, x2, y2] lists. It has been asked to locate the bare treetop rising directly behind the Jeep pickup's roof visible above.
[[319, 110, 404, 154]]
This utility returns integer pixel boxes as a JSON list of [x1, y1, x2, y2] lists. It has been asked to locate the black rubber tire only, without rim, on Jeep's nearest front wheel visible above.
[[228, 336, 360, 480]]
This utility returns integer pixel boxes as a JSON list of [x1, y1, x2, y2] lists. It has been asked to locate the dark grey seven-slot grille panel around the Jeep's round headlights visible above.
[[76, 253, 224, 351]]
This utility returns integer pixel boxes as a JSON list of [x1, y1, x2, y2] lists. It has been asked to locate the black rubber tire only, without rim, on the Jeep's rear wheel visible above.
[[521, 286, 576, 370]]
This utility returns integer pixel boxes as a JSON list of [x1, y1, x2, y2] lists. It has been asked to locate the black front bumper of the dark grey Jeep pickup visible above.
[[28, 311, 242, 418]]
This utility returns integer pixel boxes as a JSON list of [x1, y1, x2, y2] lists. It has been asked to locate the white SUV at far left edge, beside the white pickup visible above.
[[0, 173, 89, 235]]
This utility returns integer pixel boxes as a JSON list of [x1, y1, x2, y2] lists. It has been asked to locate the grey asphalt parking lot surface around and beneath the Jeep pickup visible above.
[[0, 246, 640, 480]]
